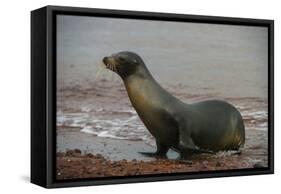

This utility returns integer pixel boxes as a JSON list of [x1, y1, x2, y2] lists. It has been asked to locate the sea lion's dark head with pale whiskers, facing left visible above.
[[103, 51, 144, 79]]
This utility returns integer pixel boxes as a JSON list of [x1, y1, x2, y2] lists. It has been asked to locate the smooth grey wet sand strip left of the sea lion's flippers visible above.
[[57, 128, 163, 161]]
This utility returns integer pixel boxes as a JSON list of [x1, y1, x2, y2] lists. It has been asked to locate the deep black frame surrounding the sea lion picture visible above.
[[31, 6, 274, 188]]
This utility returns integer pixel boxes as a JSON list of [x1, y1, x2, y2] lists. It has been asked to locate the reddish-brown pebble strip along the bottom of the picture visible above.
[[56, 149, 264, 180]]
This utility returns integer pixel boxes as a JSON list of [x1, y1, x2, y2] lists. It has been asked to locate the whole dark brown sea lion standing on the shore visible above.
[[103, 51, 245, 158]]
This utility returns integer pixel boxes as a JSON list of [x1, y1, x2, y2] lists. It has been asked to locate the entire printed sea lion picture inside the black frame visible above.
[[55, 14, 269, 180]]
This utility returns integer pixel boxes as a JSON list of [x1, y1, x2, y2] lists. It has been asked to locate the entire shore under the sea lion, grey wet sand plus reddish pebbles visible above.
[[56, 128, 267, 180]]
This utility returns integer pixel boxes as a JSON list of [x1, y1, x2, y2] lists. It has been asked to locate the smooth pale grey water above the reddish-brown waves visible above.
[[57, 15, 268, 99]]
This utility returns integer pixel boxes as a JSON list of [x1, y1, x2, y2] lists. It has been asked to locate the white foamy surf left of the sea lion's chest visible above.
[[57, 109, 153, 143]]
